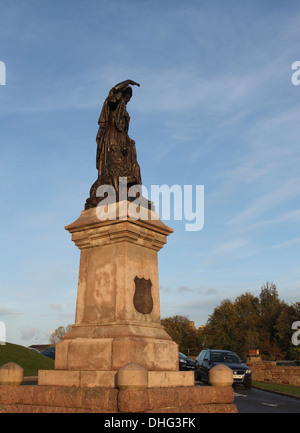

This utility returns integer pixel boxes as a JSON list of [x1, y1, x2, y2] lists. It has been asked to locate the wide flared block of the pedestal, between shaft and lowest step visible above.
[[55, 322, 178, 371]]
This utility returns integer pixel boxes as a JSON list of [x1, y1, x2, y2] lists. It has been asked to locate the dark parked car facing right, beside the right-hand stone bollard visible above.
[[195, 349, 251, 388]]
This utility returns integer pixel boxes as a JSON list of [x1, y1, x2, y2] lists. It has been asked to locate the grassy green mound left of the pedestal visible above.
[[0, 343, 54, 377]]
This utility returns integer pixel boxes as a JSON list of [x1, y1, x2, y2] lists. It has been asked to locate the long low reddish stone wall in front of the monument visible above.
[[0, 385, 238, 414]]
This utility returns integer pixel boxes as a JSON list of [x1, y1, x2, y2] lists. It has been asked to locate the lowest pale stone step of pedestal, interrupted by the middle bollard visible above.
[[38, 370, 194, 388]]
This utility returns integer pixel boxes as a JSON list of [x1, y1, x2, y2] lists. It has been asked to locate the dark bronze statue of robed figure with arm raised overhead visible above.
[[85, 80, 142, 209]]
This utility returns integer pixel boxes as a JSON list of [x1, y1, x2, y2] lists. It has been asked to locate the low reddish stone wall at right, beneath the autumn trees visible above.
[[247, 361, 300, 386]]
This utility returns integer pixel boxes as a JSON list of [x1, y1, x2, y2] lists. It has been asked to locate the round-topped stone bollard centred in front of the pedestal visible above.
[[116, 362, 148, 390]]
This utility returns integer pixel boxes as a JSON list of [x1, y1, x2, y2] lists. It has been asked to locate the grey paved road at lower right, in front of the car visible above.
[[234, 387, 300, 413]]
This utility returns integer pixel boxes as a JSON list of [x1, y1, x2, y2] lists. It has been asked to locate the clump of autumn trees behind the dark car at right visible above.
[[199, 282, 300, 359]]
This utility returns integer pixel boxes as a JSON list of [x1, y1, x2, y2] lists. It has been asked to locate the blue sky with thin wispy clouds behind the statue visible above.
[[0, 0, 300, 346]]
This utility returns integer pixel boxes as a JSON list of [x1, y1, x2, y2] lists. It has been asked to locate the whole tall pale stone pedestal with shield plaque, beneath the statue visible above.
[[38, 201, 194, 388]]
